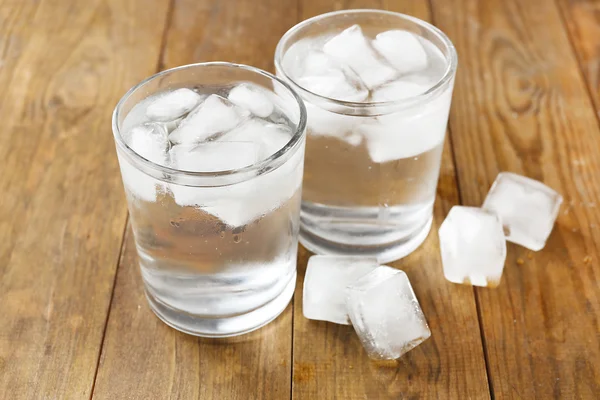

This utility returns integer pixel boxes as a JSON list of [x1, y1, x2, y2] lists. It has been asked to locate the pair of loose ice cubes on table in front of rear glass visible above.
[[302, 256, 431, 360]]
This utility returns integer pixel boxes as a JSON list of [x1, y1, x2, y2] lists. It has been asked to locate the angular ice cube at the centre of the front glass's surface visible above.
[[169, 94, 243, 144]]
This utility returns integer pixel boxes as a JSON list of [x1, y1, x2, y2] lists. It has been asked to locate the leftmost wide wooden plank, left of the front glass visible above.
[[0, 0, 171, 399]]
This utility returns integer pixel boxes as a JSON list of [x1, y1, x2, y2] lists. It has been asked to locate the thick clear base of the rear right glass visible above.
[[299, 203, 433, 264]]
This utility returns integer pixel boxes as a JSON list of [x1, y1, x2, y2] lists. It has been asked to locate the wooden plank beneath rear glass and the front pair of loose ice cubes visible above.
[[292, 0, 489, 400]]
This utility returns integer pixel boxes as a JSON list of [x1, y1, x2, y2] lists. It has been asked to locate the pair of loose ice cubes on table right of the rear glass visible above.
[[438, 172, 562, 287]]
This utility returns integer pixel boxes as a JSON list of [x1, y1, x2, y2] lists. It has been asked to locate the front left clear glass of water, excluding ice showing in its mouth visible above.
[[113, 63, 306, 337]]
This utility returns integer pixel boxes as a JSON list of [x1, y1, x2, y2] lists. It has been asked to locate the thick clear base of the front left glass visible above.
[[146, 273, 296, 338]]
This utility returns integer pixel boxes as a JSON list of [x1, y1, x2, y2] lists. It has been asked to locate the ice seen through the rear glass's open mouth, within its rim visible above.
[[284, 25, 436, 102]]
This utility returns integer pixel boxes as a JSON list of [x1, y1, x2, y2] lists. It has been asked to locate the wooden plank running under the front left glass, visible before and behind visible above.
[[94, 0, 296, 400]]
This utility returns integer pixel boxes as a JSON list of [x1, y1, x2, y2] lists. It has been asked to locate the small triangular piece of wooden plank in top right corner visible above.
[[557, 0, 600, 112]]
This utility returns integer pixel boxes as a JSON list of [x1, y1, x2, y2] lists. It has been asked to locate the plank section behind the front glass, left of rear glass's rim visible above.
[[162, 0, 297, 72]]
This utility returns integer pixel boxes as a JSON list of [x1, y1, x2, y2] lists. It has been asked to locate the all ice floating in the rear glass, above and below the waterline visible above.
[[283, 25, 451, 163]]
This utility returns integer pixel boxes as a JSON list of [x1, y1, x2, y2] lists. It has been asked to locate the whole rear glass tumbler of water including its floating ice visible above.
[[275, 10, 457, 262]]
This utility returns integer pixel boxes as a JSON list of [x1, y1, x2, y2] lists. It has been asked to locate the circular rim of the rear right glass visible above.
[[275, 8, 458, 115]]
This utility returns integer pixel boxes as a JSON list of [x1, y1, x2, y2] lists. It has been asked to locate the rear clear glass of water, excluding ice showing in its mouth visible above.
[[275, 10, 457, 262]]
